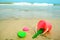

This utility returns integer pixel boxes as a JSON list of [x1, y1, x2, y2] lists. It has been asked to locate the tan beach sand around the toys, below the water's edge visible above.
[[0, 18, 60, 40]]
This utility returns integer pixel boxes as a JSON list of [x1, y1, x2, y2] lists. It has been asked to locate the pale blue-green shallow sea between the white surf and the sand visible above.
[[0, 5, 60, 19]]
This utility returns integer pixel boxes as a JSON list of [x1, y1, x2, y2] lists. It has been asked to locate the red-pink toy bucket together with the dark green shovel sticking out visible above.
[[32, 20, 52, 38]]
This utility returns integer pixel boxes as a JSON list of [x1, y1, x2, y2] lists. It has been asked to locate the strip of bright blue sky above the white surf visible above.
[[0, 0, 60, 4]]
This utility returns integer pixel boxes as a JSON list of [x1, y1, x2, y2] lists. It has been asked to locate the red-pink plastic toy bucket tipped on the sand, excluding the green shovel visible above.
[[37, 20, 52, 34]]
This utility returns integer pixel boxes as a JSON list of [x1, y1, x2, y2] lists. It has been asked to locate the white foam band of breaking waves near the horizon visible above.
[[0, 2, 54, 6]]
